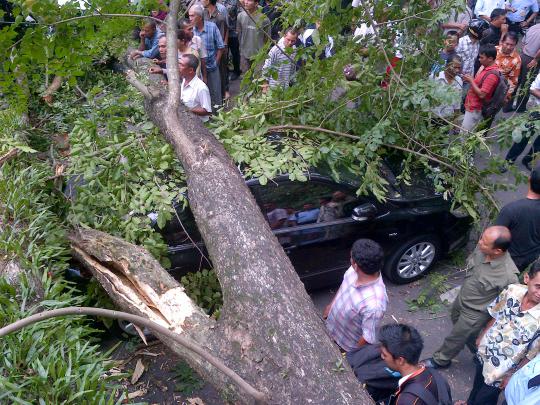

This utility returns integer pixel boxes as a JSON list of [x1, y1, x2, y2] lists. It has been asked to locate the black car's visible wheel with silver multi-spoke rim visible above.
[[384, 235, 441, 284]]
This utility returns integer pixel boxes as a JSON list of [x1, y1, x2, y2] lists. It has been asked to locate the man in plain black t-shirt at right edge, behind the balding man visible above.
[[495, 164, 540, 271]]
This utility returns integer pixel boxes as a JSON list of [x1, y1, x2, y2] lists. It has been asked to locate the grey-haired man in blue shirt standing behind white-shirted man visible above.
[[188, 4, 225, 108]]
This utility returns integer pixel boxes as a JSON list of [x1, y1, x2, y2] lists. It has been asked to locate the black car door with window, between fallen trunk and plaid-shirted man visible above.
[[252, 178, 373, 289]]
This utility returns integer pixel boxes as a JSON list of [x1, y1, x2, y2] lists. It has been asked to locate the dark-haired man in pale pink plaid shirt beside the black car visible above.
[[323, 239, 388, 352]]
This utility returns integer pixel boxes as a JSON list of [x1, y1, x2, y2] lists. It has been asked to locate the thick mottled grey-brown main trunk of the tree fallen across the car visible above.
[[107, 6, 372, 404]]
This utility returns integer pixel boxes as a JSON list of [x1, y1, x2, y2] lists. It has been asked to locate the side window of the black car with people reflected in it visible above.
[[257, 181, 358, 229]]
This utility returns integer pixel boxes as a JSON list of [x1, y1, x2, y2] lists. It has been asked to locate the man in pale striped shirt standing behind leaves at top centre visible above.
[[262, 28, 298, 93]]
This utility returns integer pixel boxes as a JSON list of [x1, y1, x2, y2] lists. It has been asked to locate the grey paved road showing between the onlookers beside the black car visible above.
[[312, 131, 528, 400]]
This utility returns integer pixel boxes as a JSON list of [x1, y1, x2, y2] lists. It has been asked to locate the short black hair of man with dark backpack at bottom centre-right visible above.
[[379, 323, 424, 365]]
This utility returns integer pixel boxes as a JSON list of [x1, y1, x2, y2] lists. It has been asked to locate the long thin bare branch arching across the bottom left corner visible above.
[[0, 307, 267, 404]]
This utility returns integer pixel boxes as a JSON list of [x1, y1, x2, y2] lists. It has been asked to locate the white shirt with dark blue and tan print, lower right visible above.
[[478, 284, 540, 386]]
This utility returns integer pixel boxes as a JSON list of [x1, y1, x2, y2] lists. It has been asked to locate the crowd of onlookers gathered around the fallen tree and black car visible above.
[[126, 0, 540, 405]]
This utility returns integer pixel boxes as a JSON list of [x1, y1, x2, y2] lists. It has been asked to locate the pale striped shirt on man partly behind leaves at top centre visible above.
[[262, 38, 296, 87]]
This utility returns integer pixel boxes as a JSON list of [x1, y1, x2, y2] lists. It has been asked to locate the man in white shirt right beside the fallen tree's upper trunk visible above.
[[178, 54, 212, 122]]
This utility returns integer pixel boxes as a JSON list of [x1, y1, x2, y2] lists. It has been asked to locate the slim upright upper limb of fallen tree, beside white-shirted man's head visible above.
[[167, 0, 180, 111]]
